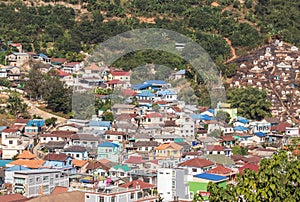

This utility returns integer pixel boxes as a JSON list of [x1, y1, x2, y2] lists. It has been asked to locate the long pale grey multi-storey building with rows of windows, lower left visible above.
[[13, 169, 69, 198]]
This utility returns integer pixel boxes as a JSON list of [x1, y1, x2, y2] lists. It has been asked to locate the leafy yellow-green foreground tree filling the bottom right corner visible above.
[[208, 151, 300, 202]]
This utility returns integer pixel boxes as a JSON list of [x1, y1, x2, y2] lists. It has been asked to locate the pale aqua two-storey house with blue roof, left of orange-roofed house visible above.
[[97, 142, 121, 163]]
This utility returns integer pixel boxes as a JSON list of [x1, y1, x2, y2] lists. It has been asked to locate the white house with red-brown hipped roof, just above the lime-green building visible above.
[[178, 158, 215, 175]]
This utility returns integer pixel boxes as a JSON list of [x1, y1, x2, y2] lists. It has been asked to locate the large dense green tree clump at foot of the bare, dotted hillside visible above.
[[227, 87, 272, 120]]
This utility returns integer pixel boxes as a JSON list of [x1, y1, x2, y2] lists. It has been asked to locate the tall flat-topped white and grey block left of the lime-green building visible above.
[[157, 168, 191, 201]]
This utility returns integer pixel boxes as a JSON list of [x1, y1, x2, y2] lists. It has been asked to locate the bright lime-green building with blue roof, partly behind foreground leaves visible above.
[[189, 173, 228, 200]]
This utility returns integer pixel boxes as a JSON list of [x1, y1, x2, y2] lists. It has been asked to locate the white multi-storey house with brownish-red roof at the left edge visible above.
[[2, 128, 29, 159]]
